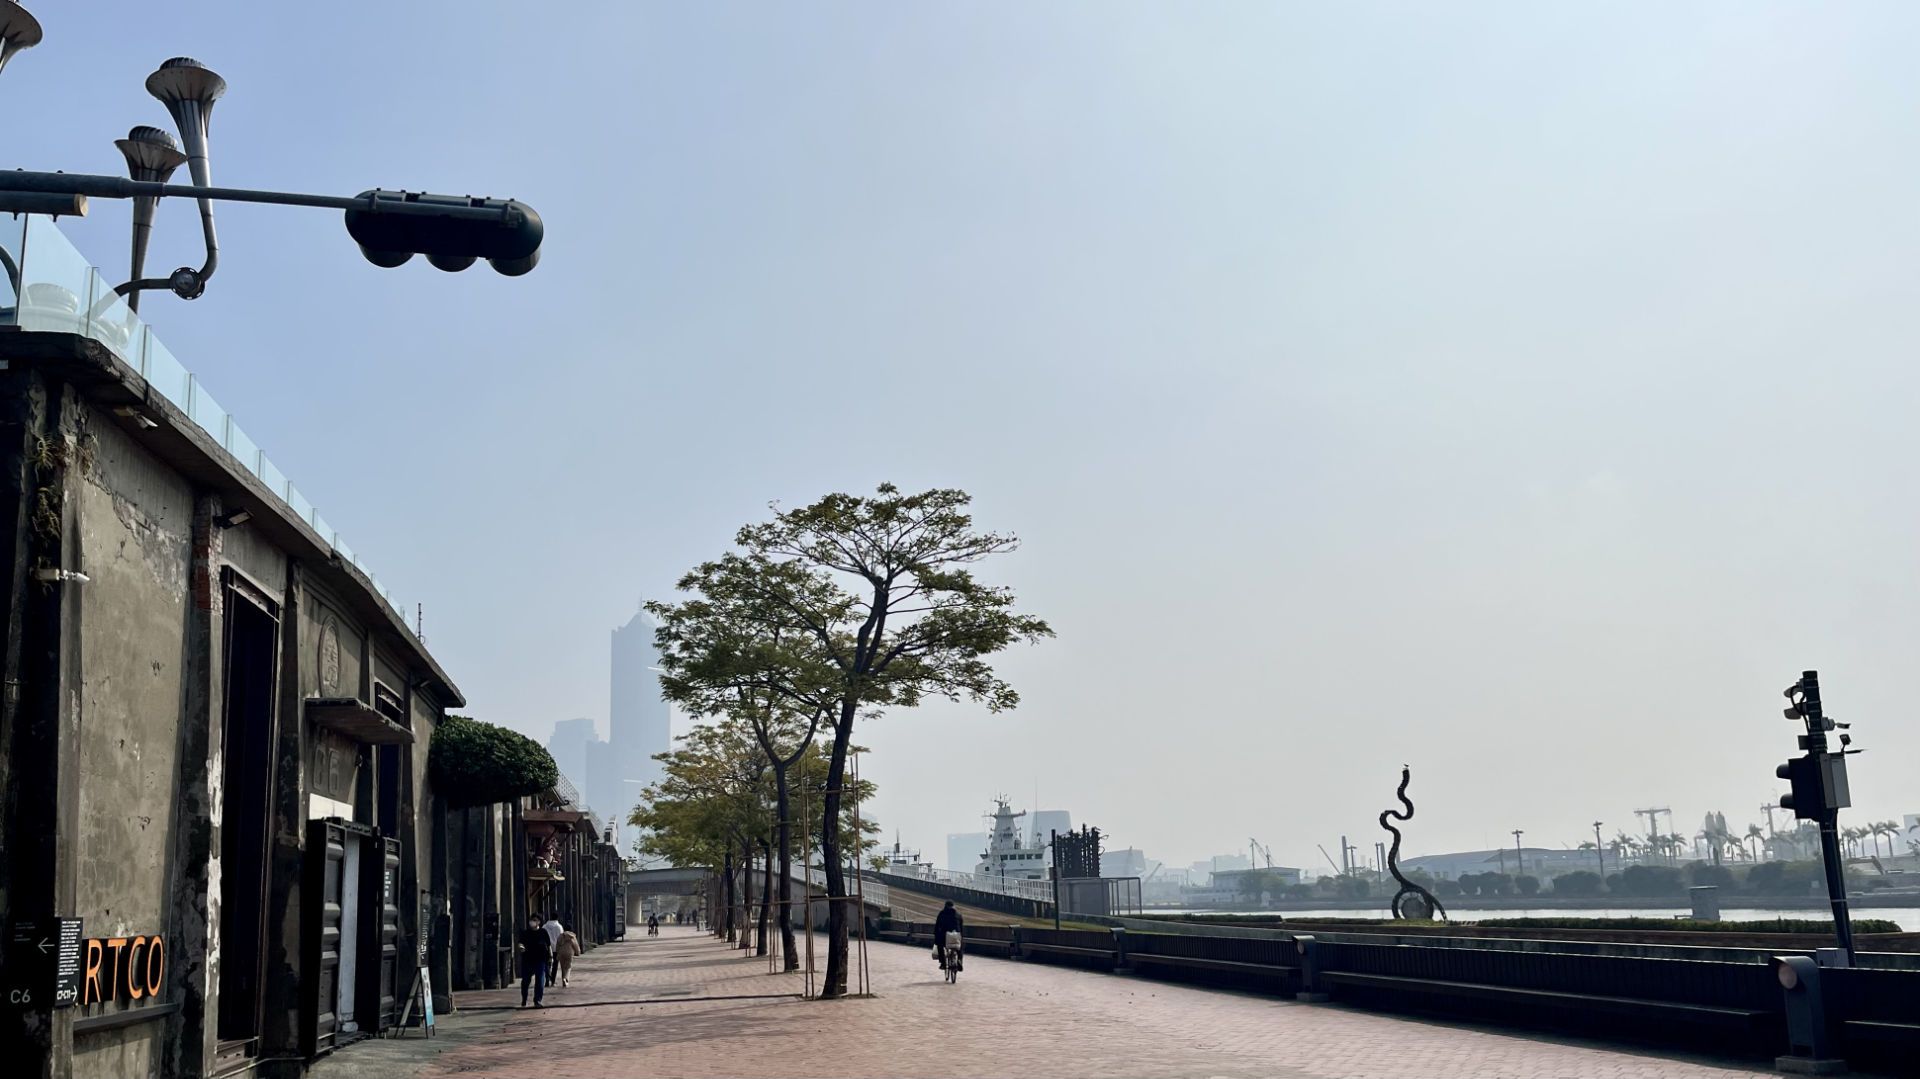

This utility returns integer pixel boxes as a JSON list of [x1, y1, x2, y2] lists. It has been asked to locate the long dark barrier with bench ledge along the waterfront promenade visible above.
[[879, 920, 1920, 1073]]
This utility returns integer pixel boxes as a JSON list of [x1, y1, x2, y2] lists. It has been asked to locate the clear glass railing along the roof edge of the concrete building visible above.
[[0, 215, 413, 632]]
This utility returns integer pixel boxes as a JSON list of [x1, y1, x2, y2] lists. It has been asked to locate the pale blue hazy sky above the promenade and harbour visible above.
[[15, 0, 1920, 868]]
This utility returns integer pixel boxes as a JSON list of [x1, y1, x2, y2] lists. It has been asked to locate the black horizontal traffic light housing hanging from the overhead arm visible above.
[[346, 190, 545, 276]]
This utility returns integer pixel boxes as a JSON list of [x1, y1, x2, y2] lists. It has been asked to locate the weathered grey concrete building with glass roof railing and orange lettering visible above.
[[0, 217, 556, 1077]]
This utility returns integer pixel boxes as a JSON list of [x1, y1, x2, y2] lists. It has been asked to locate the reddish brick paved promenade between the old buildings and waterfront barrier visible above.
[[349, 927, 1764, 1079]]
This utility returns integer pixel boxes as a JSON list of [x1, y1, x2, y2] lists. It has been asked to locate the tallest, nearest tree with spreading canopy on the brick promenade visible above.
[[655, 484, 1052, 998]]
